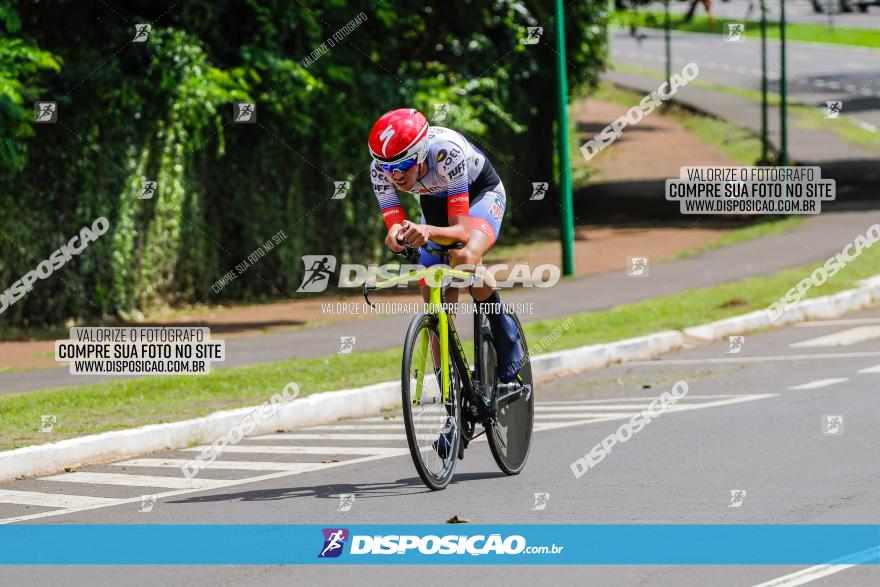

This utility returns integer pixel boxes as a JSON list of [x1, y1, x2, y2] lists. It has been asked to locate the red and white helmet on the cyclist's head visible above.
[[370, 108, 428, 163]]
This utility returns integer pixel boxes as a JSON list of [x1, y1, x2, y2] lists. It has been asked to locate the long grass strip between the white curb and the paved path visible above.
[[0, 242, 880, 449]]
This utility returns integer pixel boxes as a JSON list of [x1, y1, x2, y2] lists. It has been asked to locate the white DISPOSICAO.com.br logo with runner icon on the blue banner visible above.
[[318, 528, 564, 558]]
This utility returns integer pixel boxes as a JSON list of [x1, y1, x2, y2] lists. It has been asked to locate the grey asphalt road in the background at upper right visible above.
[[611, 29, 880, 127]]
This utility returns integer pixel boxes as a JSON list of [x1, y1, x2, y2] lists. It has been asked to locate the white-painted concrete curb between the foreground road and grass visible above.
[[0, 275, 880, 481]]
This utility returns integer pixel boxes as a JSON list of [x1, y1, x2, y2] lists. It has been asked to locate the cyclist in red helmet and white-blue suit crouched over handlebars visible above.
[[369, 108, 522, 383]]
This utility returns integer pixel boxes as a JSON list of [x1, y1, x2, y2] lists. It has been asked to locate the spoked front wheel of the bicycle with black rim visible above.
[[401, 314, 461, 491]]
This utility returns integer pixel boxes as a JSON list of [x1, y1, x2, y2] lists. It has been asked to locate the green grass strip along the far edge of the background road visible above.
[[611, 11, 880, 48]]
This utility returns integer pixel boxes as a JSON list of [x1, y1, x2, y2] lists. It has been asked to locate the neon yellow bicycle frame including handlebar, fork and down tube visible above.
[[364, 267, 479, 403]]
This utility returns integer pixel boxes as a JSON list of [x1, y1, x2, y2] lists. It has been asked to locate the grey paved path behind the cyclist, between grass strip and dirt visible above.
[[0, 210, 880, 393]]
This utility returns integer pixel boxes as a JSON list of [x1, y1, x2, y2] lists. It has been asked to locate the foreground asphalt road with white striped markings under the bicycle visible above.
[[0, 308, 880, 587]]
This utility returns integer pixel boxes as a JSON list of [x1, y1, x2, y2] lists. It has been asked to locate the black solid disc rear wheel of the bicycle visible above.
[[486, 316, 535, 475]]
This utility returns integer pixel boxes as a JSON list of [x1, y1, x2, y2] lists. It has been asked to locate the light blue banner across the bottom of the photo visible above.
[[0, 524, 880, 565]]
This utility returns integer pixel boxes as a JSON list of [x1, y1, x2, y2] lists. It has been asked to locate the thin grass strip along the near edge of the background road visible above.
[[614, 63, 880, 158]]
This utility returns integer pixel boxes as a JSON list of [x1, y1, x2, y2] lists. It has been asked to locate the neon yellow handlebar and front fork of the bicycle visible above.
[[370, 267, 478, 403]]
